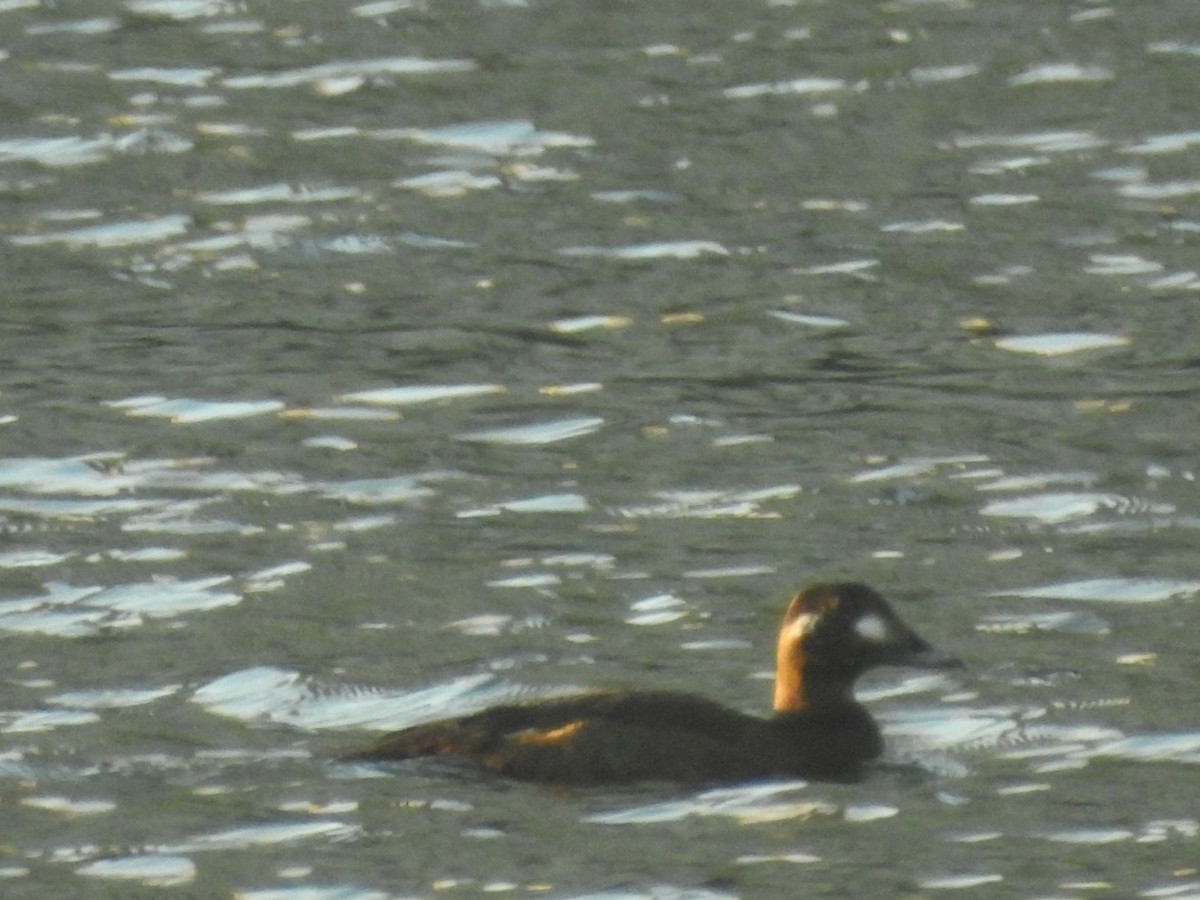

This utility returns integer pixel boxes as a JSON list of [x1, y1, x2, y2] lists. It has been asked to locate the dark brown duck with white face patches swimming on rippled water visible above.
[[346, 583, 962, 785]]
